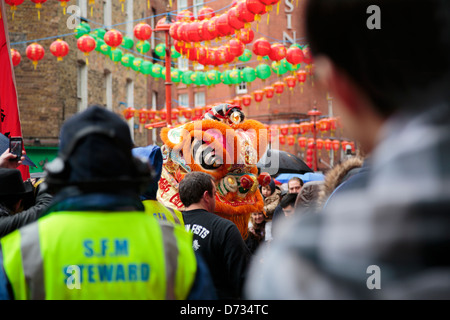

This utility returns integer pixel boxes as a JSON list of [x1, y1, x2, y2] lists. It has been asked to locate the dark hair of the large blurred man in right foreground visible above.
[[305, 0, 450, 117]]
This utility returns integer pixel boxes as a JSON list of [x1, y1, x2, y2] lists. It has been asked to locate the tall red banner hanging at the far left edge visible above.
[[0, 0, 30, 180]]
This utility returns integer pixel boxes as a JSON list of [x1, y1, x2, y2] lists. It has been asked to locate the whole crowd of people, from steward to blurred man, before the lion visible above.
[[0, 0, 450, 300]]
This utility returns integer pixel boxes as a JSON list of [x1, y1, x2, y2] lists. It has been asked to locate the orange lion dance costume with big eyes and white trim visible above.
[[157, 104, 270, 239]]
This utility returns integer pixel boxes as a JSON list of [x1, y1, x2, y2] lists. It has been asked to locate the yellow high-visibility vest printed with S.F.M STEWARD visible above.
[[1, 212, 197, 300]]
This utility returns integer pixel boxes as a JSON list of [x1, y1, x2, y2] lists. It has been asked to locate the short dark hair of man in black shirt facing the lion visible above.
[[178, 171, 213, 207]]
